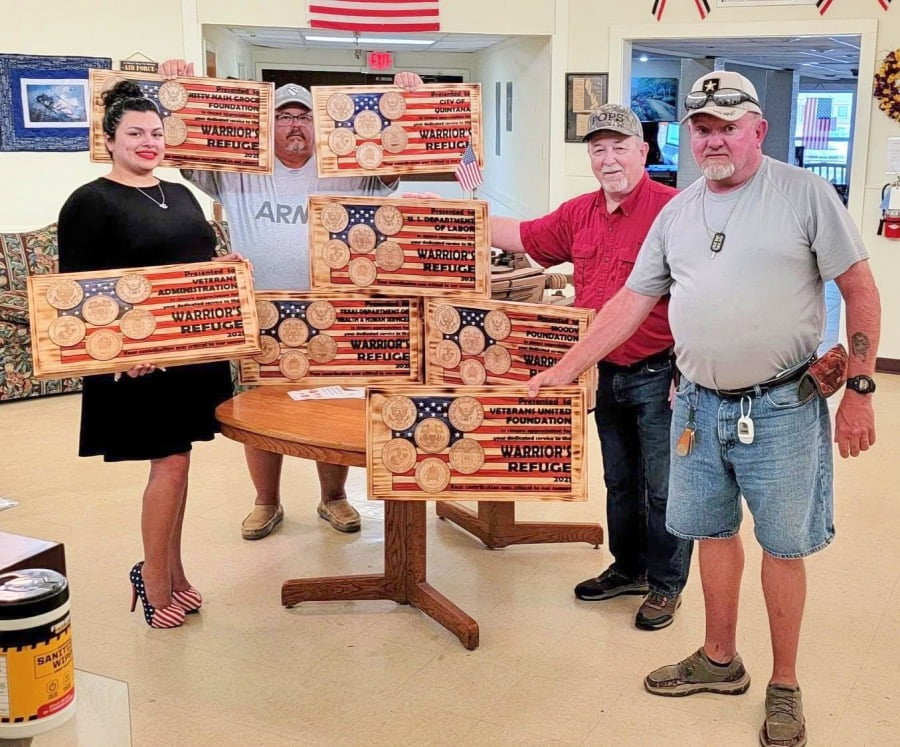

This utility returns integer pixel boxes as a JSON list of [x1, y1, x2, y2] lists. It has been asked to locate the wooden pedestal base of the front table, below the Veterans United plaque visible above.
[[281, 501, 478, 651]]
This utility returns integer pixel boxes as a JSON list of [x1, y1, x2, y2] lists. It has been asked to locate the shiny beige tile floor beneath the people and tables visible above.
[[0, 376, 900, 747]]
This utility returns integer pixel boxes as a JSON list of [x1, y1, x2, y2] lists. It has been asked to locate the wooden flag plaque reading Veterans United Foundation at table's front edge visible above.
[[366, 386, 587, 501]]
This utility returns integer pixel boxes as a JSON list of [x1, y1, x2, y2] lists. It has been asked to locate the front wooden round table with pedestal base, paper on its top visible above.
[[216, 386, 478, 650]]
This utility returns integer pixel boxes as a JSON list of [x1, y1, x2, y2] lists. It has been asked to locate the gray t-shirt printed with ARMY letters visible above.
[[181, 156, 396, 290]]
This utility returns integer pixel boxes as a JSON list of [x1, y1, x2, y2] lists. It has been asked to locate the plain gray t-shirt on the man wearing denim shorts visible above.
[[626, 158, 868, 389]]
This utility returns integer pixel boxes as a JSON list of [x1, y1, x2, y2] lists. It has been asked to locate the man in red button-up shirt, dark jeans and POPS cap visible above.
[[491, 104, 691, 630]]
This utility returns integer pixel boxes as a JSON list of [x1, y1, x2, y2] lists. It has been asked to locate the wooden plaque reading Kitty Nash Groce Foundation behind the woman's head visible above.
[[90, 70, 274, 174]]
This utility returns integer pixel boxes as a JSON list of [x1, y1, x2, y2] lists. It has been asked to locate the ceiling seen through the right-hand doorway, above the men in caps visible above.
[[633, 36, 859, 80]]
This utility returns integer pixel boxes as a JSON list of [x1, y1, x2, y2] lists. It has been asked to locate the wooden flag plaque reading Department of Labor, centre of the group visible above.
[[309, 195, 491, 298]]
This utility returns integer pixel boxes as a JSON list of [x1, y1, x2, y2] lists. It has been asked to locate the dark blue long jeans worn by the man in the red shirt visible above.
[[594, 355, 693, 596]]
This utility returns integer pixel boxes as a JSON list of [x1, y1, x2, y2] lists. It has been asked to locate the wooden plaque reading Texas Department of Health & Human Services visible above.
[[241, 291, 422, 386]]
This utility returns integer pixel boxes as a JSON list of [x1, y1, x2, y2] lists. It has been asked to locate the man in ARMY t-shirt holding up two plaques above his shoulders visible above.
[[160, 60, 422, 540]]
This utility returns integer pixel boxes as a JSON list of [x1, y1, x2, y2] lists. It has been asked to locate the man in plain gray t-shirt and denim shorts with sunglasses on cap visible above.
[[529, 71, 881, 747]]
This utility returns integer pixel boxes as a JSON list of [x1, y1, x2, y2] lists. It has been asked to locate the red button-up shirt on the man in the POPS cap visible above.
[[520, 173, 678, 366]]
